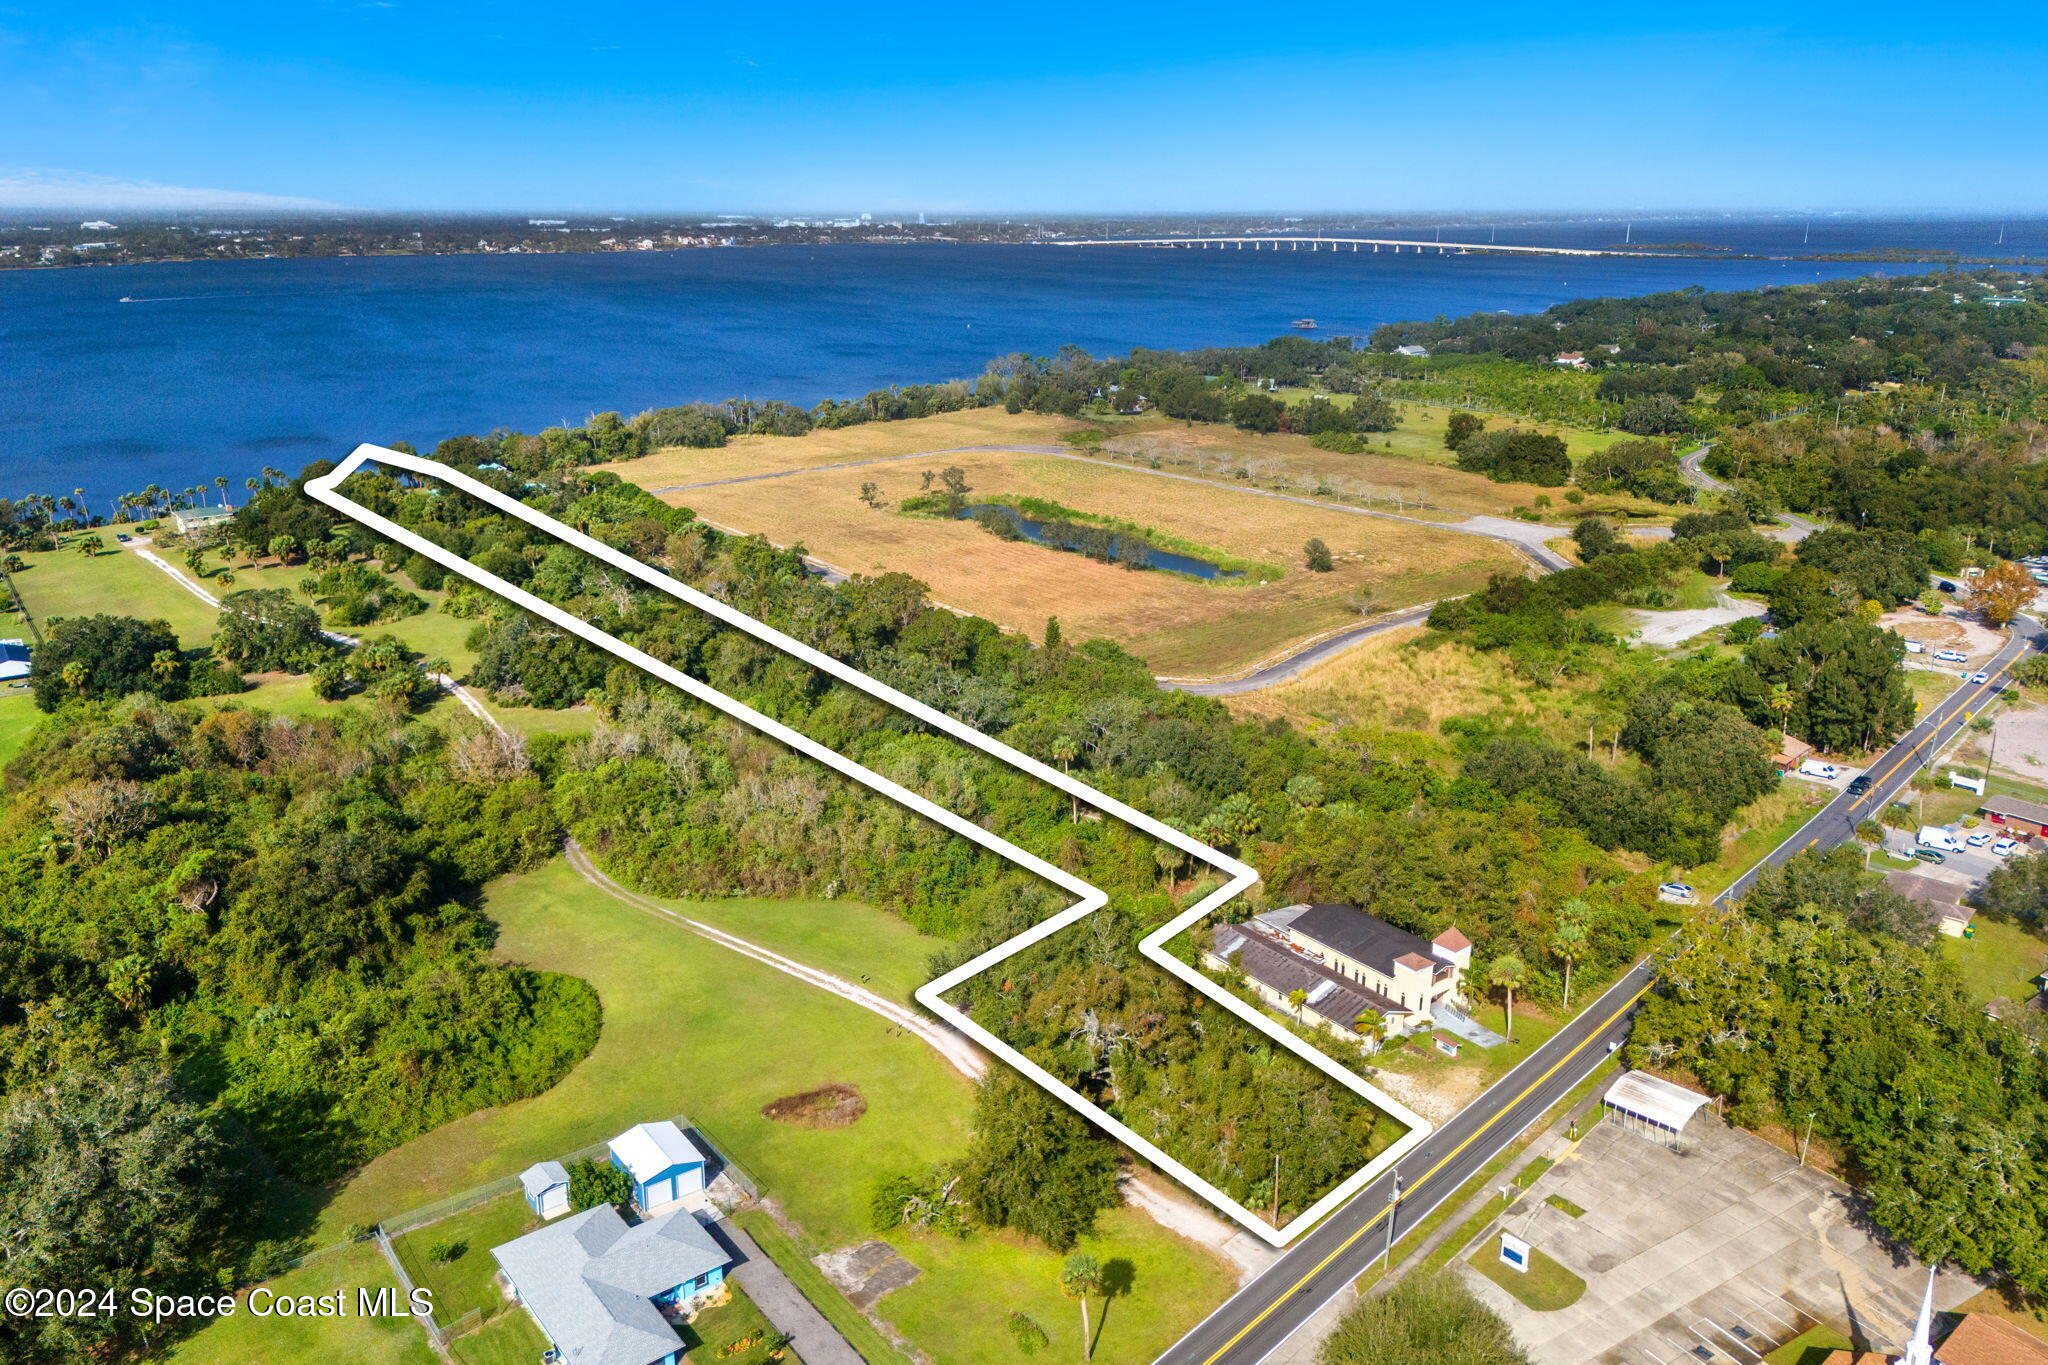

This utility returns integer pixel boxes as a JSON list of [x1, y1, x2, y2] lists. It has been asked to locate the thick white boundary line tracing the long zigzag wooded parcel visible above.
[[305, 444, 1432, 1246]]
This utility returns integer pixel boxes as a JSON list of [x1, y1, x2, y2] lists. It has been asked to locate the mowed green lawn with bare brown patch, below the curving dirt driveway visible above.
[[315, 860, 971, 1246]]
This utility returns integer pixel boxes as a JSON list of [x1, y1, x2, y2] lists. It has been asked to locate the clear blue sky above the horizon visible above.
[[0, 0, 2048, 213]]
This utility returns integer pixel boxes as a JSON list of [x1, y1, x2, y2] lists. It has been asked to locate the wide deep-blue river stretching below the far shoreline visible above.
[[0, 223, 2015, 503]]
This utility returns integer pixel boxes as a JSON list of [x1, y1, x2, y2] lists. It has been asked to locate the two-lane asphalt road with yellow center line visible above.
[[1157, 618, 2048, 1365]]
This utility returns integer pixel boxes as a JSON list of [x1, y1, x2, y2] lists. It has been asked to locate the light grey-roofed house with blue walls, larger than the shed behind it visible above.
[[492, 1203, 731, 1365]]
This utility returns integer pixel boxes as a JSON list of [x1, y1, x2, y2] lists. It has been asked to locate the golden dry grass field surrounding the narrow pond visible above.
[[616, 435, 1522, 675]]
